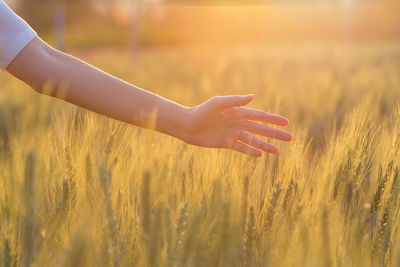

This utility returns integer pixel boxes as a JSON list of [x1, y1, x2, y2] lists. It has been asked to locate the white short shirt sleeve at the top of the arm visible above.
[[0, 0, 37, 71]]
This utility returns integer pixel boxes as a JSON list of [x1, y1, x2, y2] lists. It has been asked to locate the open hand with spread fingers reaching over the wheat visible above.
[[185, 95, 292, 157]]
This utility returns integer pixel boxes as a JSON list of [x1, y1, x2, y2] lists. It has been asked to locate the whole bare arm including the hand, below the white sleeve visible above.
[[7, 38, 291, 156]]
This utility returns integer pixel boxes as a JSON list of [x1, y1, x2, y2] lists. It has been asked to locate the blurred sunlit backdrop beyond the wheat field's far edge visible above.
[[6, 0, 400, 49]]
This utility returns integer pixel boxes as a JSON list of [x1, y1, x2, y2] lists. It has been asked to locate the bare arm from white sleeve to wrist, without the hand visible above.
[[8, 39, 189, 139]]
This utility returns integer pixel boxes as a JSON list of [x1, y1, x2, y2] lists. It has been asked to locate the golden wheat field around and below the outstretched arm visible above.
[[0, 44, 400, 267]]
